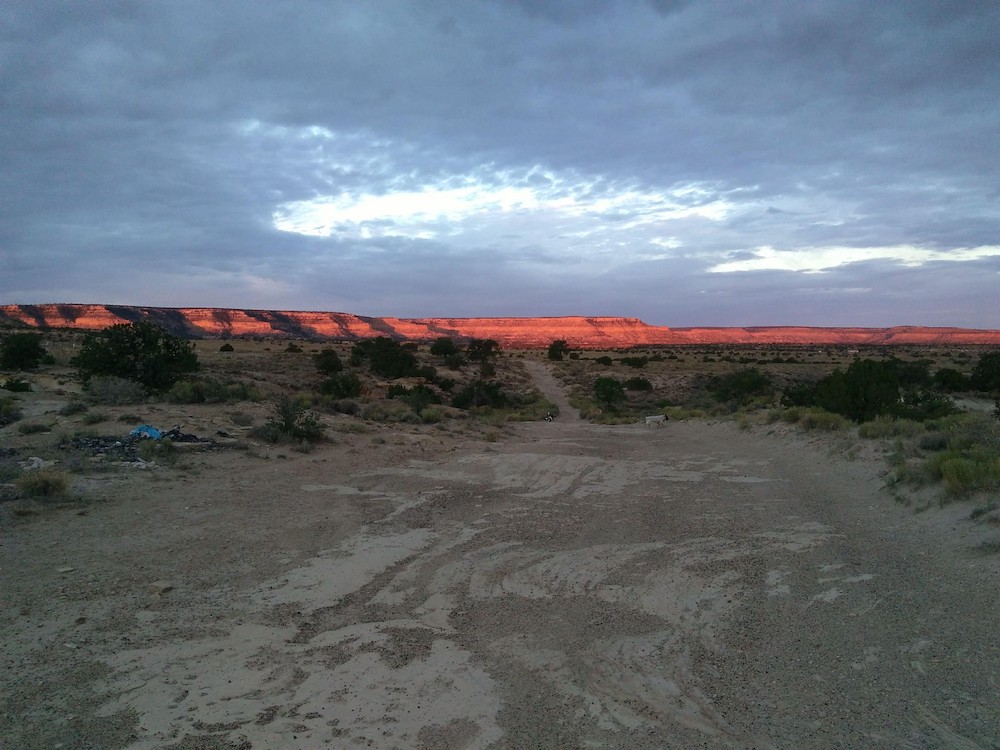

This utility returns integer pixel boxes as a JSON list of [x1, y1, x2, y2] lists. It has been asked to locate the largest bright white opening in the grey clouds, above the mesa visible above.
[[264, 123, 737, 248]]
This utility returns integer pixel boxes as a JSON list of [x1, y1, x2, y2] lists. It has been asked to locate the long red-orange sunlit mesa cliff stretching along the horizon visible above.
[[0, 305, 1000, 349]]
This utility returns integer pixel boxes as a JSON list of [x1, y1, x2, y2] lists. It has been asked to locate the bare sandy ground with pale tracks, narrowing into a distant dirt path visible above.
[[0, 365, 1000, 750]]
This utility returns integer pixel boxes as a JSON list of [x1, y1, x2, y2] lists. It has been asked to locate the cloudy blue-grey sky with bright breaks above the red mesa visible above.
[[0, 0, 1000, 328]]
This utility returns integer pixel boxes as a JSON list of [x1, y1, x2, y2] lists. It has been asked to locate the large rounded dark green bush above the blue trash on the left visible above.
[[71, 323, 199, 391]]
